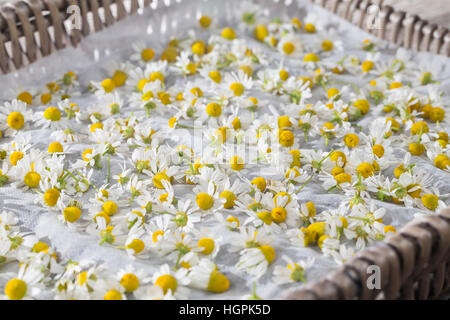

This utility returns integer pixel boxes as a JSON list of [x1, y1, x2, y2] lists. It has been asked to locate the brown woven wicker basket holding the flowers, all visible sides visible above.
[[0, 0, 450, 299]]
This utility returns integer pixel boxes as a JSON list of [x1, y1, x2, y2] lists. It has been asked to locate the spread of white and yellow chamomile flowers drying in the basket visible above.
[[0, 2, 450, 300]]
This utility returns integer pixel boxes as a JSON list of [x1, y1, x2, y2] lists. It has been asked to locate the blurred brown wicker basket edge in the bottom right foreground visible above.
[[283, 208, 450, 300]]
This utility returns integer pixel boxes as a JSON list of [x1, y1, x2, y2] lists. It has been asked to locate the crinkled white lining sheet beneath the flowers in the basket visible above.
[[0, 0, 450, 299]]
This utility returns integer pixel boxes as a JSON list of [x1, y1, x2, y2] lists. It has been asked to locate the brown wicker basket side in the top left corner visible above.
[[0, 0, 151, 73]]
